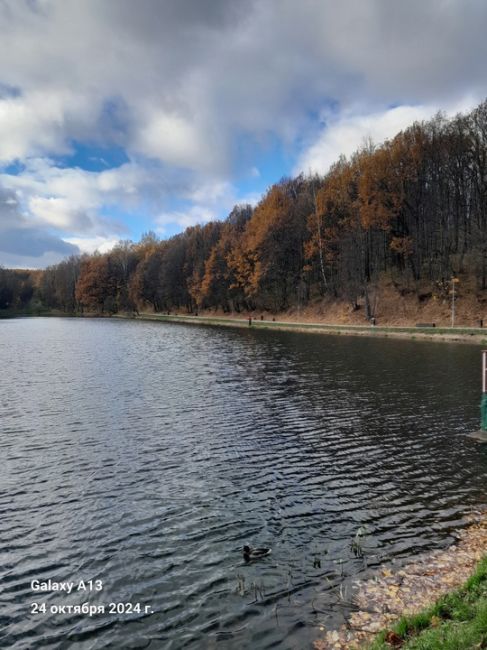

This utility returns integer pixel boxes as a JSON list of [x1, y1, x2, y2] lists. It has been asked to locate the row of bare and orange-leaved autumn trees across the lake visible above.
[[0, 101, 487, 318]]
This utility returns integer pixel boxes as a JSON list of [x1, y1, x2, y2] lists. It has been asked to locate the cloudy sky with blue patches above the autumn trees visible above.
[[0, 0, 487, 268]]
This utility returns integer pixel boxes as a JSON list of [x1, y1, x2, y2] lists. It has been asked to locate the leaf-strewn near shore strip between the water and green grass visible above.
[[313, 513, 487, 650]]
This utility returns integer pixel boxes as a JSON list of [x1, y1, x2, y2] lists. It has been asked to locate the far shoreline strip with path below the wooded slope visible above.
[[123, 312, 487, 345]]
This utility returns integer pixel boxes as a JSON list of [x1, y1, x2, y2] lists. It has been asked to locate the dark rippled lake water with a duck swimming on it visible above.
[[0, 318, 487, 650]]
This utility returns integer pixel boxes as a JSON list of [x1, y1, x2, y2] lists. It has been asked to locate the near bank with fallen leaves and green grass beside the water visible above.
[[314, 512, 487, 650]]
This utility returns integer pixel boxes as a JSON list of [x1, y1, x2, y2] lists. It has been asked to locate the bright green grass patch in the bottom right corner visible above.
[[369, 556, 487, 650]]
